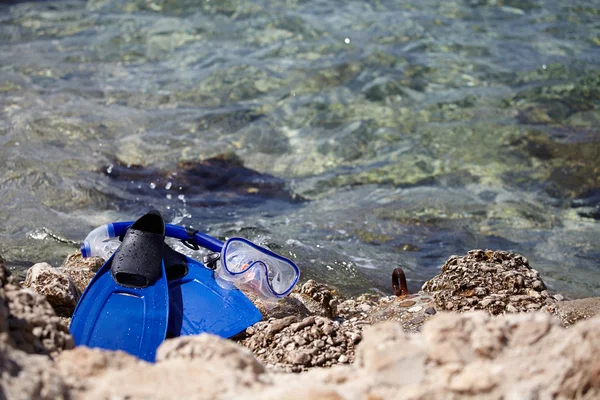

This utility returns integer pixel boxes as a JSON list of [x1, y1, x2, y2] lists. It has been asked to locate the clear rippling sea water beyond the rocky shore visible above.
[[0, 0, 600, 297]]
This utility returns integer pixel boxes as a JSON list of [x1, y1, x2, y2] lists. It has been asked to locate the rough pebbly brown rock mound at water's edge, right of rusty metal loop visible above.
[[423, 250, 547, 314]]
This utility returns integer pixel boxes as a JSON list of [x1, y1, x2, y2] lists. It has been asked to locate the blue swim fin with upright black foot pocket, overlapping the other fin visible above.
[[70, 211, 169, 361]]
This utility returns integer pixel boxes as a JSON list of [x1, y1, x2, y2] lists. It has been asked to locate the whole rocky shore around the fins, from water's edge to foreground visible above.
[[0, 250, 600, 400]]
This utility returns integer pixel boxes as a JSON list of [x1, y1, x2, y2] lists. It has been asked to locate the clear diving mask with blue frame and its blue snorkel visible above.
[[81, 221, 300, 300]]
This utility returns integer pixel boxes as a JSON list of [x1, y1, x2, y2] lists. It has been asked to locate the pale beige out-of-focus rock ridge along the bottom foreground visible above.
[[47, 311, 600, 400]]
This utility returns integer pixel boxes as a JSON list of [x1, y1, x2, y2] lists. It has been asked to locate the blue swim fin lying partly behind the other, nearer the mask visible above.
[[165, 246, 262, 338]]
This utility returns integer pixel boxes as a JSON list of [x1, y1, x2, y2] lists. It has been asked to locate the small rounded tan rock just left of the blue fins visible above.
[[23, 263, 81, 317]]
